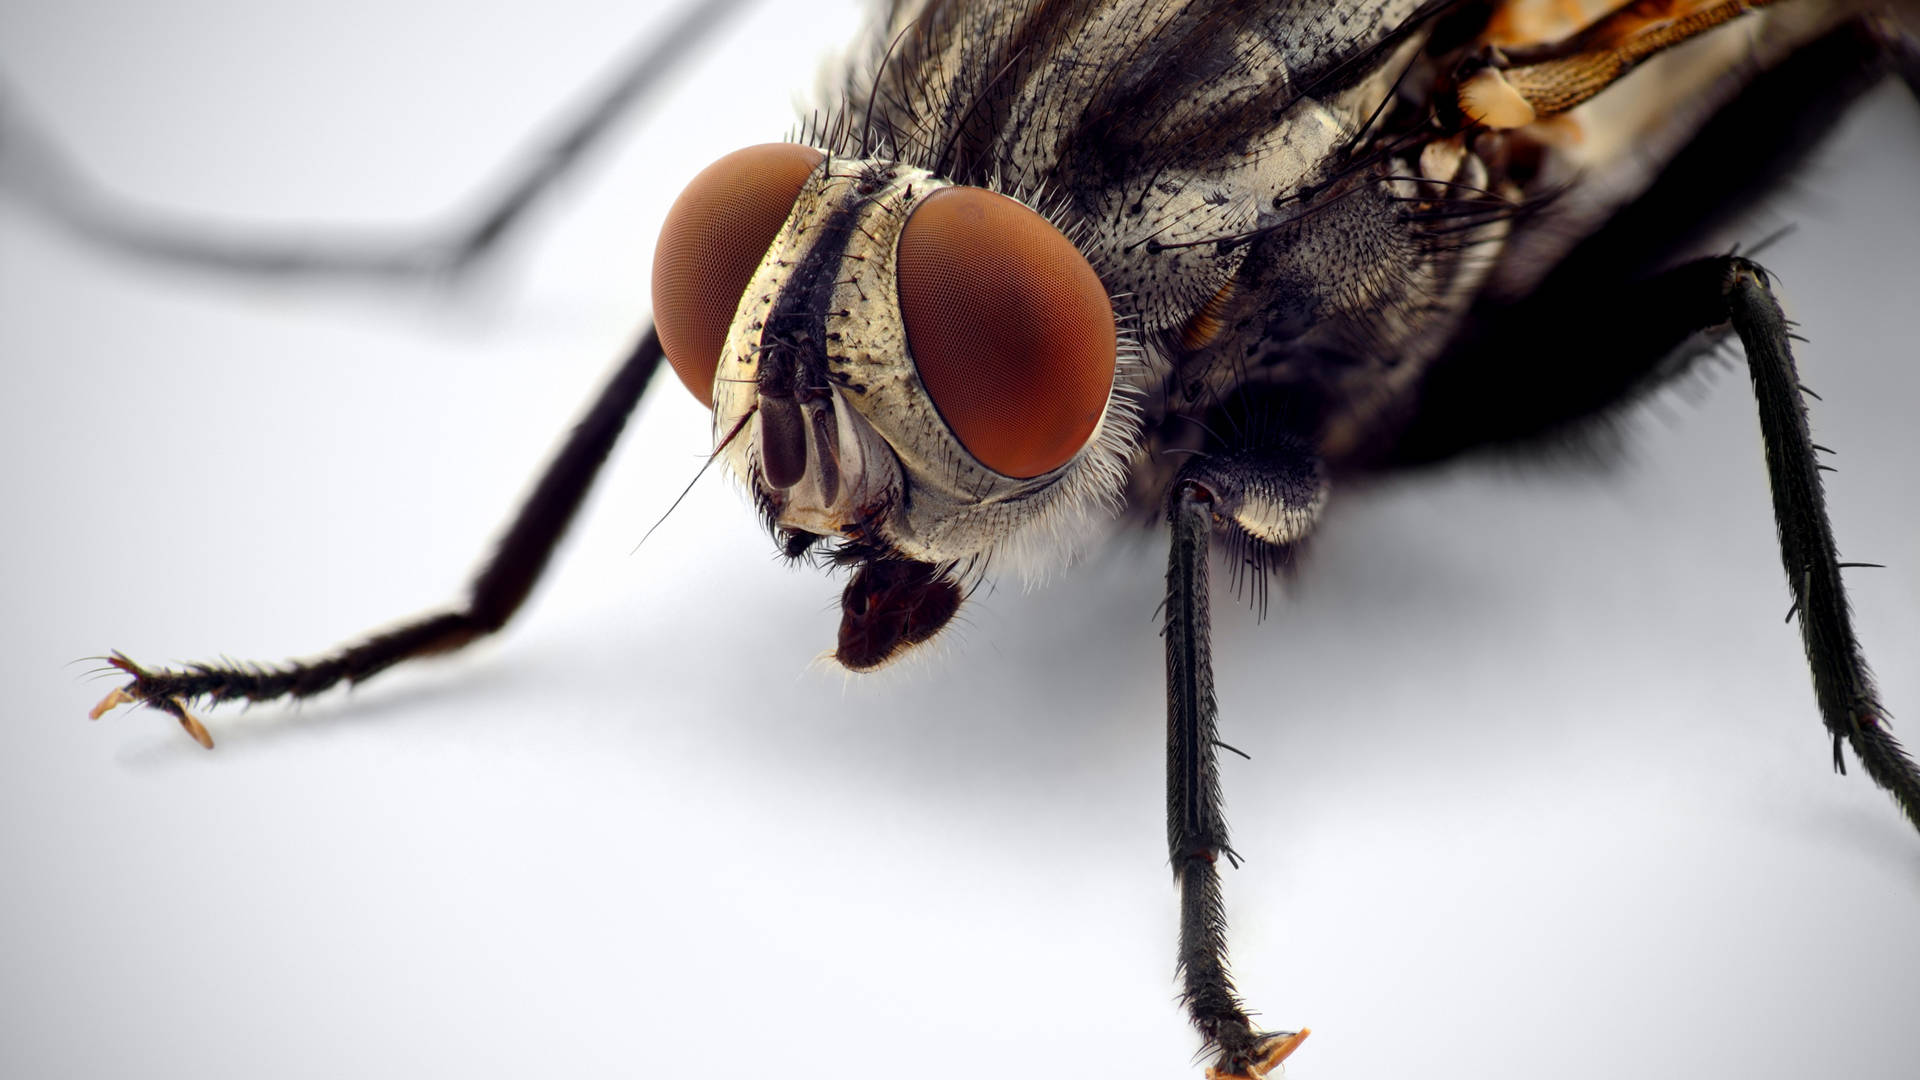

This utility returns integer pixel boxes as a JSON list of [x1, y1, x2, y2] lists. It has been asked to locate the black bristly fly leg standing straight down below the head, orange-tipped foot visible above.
[[1164, 444, 1327, 1080]]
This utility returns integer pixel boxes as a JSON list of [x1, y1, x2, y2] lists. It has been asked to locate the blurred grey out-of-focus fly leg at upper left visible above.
[[0, 0, 741, 281]]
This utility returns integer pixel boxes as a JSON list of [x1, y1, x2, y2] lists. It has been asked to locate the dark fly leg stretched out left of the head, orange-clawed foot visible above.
[[92, 329, 662, 749]]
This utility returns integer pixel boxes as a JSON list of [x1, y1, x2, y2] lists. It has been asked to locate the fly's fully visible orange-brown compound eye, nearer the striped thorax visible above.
[[899, 188, 1117, 479]]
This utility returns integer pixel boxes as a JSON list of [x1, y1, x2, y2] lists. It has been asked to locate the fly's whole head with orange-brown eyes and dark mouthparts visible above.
[[653, 144, 1139, 671]]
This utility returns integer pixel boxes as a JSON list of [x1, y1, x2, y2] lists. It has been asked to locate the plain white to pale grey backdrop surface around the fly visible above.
[[0, 0, 1920, 1080]]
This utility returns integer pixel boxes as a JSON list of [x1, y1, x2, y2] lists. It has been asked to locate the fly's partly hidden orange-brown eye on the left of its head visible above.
[[653, 142, 824, 409]]
